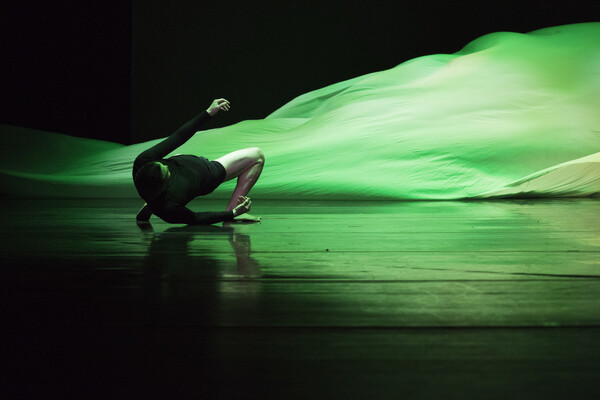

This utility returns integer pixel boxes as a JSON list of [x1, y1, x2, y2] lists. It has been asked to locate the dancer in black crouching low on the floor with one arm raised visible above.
[[133, 99, 264, 224]]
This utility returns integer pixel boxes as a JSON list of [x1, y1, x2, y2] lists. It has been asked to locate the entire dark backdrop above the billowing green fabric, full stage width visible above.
[[0, 0, 600, 144]]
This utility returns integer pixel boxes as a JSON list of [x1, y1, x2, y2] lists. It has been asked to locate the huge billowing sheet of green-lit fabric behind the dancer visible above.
[[0, 23, 600, 199]]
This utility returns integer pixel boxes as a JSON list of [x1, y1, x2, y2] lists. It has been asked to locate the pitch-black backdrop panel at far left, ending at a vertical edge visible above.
[[0, 0, 131, 143]]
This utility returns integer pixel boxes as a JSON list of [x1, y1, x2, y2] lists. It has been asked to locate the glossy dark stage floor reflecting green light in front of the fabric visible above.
[[0, 198, 600, 399]]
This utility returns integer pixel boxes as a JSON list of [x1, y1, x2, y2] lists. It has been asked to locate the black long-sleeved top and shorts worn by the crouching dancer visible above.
[[133, 111, 233, 224]]
